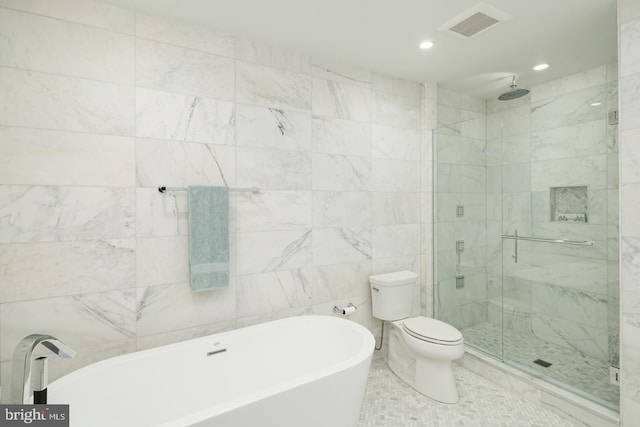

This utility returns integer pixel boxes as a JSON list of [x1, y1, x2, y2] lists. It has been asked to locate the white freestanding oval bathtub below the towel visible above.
[[48, 316, 375, 427]]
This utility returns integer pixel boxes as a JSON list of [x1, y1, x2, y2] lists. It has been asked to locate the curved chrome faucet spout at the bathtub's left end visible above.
[[3, 334, 76, 404]]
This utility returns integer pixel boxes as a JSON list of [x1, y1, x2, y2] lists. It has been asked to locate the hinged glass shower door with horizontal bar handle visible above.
[[500, 83, 619, 408]]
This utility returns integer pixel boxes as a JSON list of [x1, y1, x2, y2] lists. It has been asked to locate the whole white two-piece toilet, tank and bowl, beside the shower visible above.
[[369, 271, 464, 403]]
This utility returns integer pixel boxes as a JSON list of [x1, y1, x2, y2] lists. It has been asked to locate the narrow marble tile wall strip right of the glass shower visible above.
[[618, 0, 640, 426]]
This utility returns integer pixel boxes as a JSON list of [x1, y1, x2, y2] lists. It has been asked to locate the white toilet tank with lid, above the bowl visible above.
[[369, 271, 418, 321]]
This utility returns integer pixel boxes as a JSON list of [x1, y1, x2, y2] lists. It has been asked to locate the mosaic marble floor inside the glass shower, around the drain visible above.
[[462, 322, 620, 409]]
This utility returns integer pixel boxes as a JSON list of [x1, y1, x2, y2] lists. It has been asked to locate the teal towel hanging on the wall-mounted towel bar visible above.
[[187, 187, 229, 291]]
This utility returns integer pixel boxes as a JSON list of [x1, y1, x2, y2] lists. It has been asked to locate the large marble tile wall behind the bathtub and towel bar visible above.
[[0, 0, 437, 385]]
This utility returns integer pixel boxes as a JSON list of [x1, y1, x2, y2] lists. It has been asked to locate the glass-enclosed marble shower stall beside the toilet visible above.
[[433, 72, 619, 410]]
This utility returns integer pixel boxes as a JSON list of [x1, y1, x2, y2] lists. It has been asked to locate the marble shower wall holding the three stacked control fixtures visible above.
[[434, 88, 488, 328]]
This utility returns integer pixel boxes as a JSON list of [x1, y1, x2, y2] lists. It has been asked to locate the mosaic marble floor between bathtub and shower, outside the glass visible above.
[[359, 353, 577, 427]]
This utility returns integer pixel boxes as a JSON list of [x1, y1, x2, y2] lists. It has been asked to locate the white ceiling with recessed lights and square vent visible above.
[[103, 0, 617, 99]]
